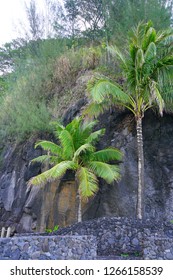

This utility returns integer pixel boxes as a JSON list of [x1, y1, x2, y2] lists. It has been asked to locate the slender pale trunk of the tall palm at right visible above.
[[136, 117, 144, 219]]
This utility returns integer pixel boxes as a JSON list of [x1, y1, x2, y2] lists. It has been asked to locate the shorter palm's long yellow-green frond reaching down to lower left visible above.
[[28, 161, 77, 186]]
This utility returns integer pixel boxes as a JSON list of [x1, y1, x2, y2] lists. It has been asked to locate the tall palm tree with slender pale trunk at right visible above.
[[86, 22, 173, 219]]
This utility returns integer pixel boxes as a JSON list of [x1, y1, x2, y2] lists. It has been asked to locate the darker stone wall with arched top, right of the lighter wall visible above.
[[52, 217, 173, 260]]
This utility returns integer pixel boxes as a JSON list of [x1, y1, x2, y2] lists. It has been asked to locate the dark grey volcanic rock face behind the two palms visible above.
[[0, 108, 173, 232]]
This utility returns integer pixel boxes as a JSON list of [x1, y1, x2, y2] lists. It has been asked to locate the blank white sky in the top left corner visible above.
[[0, 0, 59, 46]]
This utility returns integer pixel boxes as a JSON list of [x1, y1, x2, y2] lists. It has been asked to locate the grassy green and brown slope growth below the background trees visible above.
[[0, 39, 103, 141]]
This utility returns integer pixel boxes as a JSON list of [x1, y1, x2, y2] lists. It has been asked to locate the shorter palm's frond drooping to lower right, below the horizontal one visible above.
[[89, 161, 120, 184]]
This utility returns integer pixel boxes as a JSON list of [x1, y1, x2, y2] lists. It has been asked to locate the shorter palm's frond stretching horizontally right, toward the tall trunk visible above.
[[93, 147, 123, 162]]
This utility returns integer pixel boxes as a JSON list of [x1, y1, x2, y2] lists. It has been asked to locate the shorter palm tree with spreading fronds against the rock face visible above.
[[28, 118, 122, 222]]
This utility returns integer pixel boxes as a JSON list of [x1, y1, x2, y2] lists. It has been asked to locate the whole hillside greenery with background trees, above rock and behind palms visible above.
[[0, 0, 173, 142]]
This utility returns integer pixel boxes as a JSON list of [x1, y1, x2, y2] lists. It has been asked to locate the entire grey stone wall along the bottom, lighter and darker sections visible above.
[[0, 217, 173, 260]]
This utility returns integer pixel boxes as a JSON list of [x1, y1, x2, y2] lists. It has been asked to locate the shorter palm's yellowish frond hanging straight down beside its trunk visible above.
[[77, 167, 98, 198]]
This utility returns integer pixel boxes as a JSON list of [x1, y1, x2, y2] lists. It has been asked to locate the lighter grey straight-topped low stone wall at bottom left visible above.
[[0, 236, 97, 260]]
